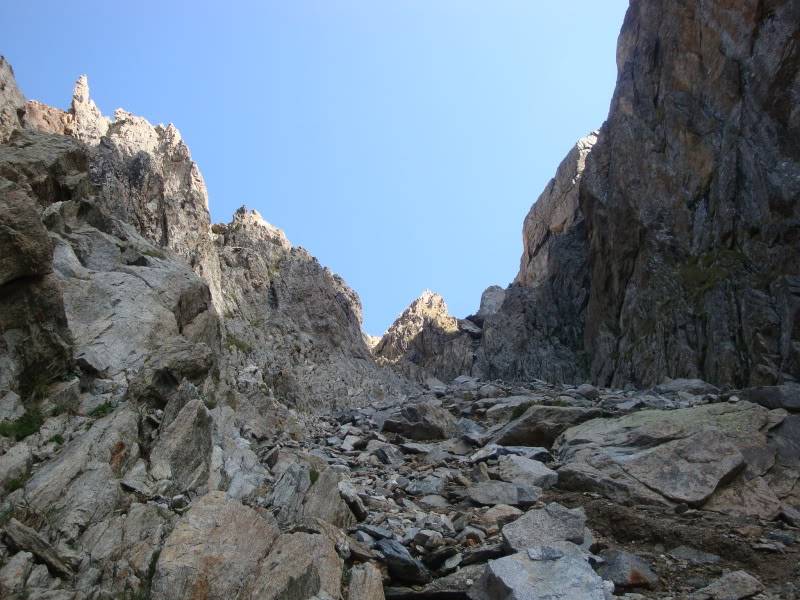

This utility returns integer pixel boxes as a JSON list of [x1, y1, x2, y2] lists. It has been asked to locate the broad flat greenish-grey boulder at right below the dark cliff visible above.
[[556, 402, 785, 518]]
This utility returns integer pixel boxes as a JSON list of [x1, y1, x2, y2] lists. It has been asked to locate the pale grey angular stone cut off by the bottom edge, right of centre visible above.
[[467, 542, 606, 600]]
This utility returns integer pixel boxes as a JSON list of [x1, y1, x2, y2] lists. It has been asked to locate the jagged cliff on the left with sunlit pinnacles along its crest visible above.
[[0, 69, 413, 410]]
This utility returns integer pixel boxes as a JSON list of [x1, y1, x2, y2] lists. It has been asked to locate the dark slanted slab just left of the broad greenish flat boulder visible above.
[[492, 405, 601, 446]]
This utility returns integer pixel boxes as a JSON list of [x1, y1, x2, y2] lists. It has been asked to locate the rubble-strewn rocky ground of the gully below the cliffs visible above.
[[0, 377, 800, 600]]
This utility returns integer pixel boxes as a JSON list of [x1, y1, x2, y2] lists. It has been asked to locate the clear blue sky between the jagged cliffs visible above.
[[0, 0, 628, 334]]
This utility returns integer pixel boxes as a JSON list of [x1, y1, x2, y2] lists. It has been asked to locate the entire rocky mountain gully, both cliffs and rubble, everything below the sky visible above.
[[0, 0, 800, 600]]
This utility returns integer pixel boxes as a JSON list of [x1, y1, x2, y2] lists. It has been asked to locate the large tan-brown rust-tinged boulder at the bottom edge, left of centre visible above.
[[152, 492, 279, 600]]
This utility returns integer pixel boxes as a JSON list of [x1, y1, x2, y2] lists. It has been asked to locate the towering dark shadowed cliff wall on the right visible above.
[[388, 0, 800, 386]]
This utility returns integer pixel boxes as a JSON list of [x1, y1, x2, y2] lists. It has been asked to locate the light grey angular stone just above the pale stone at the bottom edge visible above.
[[502, 502, 586, 551]]
